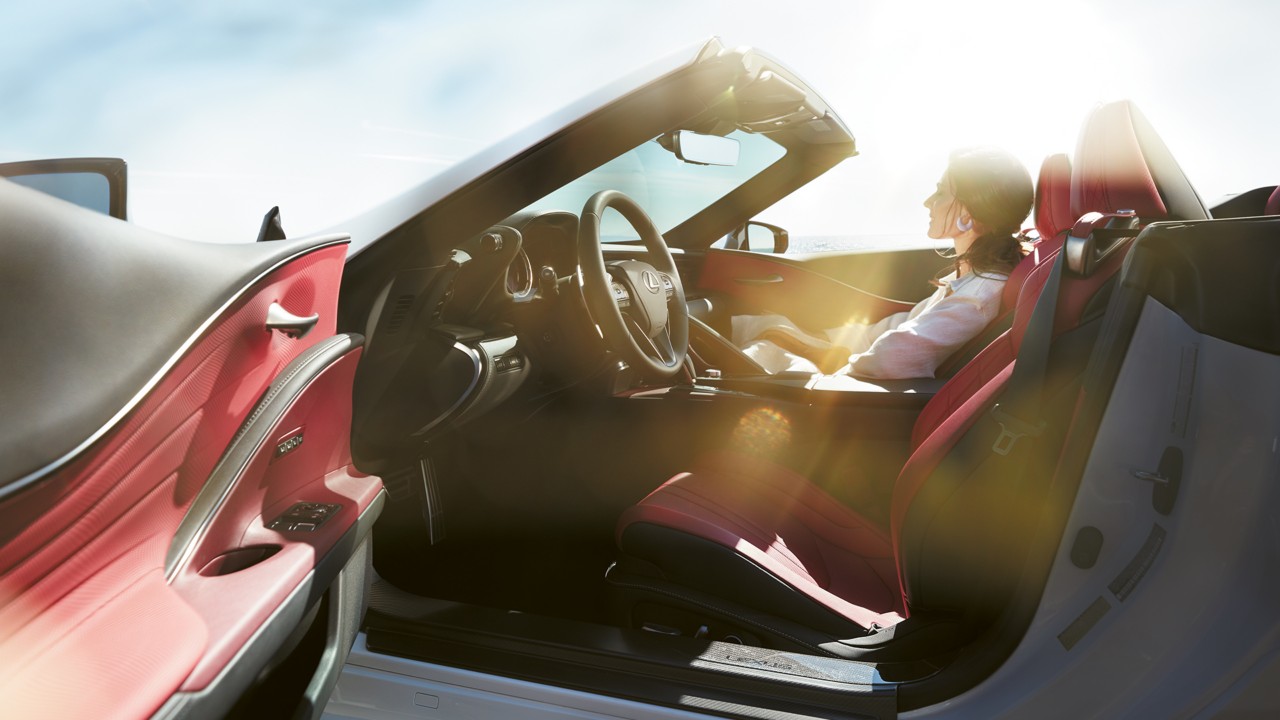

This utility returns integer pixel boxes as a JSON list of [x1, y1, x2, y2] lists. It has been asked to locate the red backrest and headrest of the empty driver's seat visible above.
[[891, 101, 1208, 612]]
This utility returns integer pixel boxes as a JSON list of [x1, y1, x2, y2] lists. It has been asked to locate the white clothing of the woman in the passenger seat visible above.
[[732, 273, 1009, 379]]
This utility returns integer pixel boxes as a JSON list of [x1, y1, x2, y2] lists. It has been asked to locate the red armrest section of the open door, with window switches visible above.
[[172, 336, 381, 692]]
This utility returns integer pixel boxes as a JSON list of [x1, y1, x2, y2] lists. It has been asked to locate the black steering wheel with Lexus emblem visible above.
[[577, 190, 689, 380]]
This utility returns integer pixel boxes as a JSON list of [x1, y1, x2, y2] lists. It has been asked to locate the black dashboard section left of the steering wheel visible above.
[[355, 211, 594, 457]]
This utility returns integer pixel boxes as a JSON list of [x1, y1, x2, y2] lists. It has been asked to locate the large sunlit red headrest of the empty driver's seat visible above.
[[1071, 100, 1208, 223]]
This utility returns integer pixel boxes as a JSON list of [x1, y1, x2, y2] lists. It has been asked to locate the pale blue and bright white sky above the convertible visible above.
[[0, 0, 1280, 241]]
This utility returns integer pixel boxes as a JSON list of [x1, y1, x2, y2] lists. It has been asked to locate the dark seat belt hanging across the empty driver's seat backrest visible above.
[[991, 249, 1066, 455]]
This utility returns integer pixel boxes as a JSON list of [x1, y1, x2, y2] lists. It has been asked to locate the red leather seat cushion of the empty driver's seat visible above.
[[618, 452, 902, 628]]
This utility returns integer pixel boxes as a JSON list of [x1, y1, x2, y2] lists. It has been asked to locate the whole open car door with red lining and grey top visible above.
[[0, 181, 384, 717]]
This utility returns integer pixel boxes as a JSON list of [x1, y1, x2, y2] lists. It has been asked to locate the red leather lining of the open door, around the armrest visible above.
[[0, 243, 380, 717]]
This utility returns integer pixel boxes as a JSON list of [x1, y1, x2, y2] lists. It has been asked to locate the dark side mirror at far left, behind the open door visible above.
[[0, 158, 128, 220]]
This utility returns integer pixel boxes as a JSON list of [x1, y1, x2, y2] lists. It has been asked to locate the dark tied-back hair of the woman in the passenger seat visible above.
[[947, 146, 1036, 274]]
